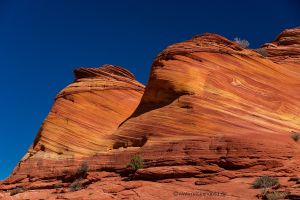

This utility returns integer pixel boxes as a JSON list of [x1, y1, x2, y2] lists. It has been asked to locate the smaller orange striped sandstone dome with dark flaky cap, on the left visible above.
[[29, 65, 144, 157]]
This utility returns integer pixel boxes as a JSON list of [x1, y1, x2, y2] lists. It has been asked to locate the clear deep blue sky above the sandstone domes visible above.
[[0, 0, 300, 179]]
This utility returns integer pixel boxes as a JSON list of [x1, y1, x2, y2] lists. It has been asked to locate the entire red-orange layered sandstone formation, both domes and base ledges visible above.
[[0, 28, 300, 199]]
